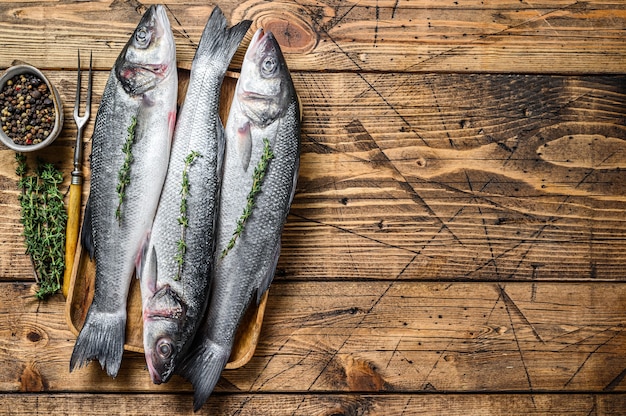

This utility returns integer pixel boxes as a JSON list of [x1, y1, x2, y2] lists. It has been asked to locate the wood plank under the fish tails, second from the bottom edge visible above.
[[0, 281, 626, 393]]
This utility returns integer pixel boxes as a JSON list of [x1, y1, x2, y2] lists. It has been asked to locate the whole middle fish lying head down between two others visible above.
[[141, 7, 251, 384]]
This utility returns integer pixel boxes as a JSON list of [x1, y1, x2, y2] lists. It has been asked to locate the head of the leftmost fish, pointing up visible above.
[[115, 5, 176, 96]]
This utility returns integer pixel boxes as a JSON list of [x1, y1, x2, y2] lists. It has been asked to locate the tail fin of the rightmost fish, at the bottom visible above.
[[177, 340, 230, 412]]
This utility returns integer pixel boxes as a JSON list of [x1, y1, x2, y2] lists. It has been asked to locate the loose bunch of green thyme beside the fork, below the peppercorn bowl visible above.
[[15, 153, 67, 299]]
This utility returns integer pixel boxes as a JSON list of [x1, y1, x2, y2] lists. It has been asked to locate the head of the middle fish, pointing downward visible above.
[[143, 285, 187, 384]]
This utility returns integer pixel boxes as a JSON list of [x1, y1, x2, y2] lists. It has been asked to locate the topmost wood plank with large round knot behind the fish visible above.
[[0, 0, 626, 74]]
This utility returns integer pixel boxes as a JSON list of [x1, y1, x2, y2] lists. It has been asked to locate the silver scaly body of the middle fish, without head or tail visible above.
[[150, 65, 223, 318]]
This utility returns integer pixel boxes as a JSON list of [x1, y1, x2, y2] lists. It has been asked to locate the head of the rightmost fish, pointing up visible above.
[[236, 28, 295, 127]]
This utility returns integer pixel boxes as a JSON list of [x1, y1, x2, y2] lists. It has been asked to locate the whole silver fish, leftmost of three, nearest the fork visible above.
[[70, 5, 178, 377]]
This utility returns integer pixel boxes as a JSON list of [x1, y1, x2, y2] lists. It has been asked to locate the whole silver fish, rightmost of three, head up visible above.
[[178, 29, 300, 410]]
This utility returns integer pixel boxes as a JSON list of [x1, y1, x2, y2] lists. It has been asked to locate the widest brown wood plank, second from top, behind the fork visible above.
[[0, 71, 626, 280]]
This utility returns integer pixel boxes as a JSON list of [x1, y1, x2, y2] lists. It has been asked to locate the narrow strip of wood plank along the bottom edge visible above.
[[0, 394, 626, 416]]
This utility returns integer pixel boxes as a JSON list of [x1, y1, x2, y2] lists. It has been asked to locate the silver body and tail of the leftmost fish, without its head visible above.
[[75, 50, 177, 377]]
